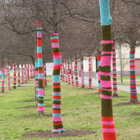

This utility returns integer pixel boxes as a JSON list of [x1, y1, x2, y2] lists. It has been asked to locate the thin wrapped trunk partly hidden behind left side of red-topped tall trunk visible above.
[[35, 61, 38, 106]]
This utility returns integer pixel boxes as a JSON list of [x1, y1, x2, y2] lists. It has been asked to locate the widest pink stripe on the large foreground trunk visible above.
[[99, 56, 111, 67]]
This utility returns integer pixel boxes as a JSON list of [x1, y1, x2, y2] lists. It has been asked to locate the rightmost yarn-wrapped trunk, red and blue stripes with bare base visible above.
[[130, 48, 138, 103]]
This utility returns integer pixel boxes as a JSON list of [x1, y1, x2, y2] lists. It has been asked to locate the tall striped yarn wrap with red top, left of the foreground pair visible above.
[[37, 22, 44, 112]]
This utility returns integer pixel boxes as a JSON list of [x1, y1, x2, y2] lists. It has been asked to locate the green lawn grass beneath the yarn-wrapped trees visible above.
[[0, 76, 140, 140]]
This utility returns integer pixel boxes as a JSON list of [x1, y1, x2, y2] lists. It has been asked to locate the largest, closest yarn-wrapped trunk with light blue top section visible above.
[[99, 0, 116, 140]]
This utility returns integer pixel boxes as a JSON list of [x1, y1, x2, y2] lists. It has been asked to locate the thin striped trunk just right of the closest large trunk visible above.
[[112, 43, 118, 96]]
